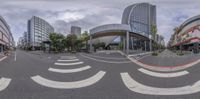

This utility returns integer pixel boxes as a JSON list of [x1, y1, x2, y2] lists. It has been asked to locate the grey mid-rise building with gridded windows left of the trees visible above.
[[27, 16, 54, 50]]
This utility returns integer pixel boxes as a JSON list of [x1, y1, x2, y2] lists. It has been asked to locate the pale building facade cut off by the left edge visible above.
[[0, 16, 15, 53]]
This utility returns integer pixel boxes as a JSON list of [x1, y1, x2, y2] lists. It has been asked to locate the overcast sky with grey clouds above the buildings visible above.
[[0, 0, 200, 42]]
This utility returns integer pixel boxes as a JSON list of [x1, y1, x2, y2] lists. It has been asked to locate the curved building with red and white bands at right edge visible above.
[[168, 15, 200, 52]]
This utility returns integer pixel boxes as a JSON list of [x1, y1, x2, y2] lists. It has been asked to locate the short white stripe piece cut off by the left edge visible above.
[[0, 77, 11, 91]]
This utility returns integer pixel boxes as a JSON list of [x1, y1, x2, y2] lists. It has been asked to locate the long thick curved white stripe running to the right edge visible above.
[[121, 73, 200, 95]]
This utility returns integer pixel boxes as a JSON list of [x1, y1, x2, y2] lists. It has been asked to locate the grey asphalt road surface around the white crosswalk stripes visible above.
[[0, 50, 200, 99]]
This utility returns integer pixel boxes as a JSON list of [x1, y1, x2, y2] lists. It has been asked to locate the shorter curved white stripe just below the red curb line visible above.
[[138, 68, 189, 78]]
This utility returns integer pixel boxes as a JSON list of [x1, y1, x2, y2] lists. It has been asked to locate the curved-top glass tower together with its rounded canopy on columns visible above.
[[90, 3, 164, 53]]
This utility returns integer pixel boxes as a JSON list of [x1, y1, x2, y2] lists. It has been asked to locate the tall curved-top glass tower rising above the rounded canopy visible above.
[[122, 3, 156, 37]]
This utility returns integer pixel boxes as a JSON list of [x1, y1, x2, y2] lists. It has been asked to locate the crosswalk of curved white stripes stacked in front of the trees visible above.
[[31, 56, 106, 89]]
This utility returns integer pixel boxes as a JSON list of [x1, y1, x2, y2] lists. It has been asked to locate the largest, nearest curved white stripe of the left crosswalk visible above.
[[31, 71, 106, 89]]
